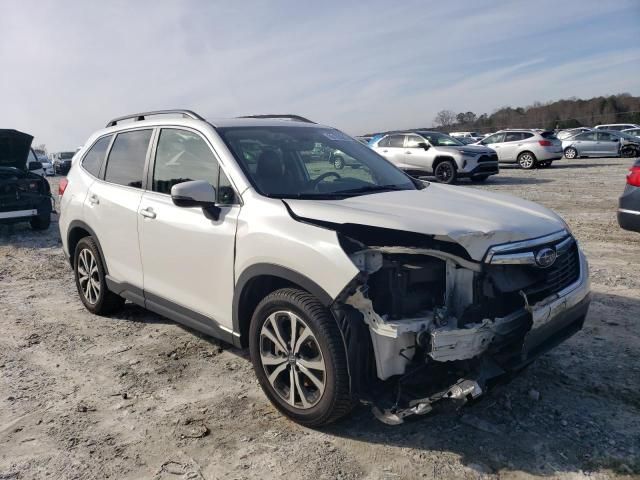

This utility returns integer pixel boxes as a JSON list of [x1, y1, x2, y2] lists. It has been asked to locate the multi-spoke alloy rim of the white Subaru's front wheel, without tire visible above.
[[260, 311, 327, 409]]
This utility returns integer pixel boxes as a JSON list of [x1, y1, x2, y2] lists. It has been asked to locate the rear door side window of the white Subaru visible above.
[[104, 130, 151, 188]]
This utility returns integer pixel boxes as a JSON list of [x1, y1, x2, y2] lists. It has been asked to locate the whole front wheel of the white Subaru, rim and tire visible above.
[[249, 288, 354, 427]]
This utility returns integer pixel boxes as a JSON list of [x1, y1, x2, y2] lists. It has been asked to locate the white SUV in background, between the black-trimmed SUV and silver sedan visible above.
[[476, 130, 562, 170]]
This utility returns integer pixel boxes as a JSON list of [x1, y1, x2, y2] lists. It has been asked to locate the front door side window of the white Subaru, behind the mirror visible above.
[[152, 128, 235, 204]]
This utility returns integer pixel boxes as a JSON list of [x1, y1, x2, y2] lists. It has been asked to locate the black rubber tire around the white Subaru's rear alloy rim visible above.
[[73, 237, 124, 315]]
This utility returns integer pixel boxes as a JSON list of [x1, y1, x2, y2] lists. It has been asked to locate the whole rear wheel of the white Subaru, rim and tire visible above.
[[73, 237, 124, 315]]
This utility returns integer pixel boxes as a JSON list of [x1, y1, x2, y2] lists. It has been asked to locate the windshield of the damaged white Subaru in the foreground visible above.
[[217, 126, 422, 199]]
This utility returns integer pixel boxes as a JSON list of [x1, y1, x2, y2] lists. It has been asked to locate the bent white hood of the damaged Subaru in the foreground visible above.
[[285, 183, 566, 261]]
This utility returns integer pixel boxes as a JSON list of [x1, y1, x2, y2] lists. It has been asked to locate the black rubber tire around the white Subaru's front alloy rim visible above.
[[249, 288, 355, 427]]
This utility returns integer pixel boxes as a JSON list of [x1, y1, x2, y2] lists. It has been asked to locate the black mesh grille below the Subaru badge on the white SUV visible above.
[[524, 241, 580, 303]]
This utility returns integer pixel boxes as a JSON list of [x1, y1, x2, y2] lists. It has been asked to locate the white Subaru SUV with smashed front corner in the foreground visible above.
[[59, 110, 589, 426]]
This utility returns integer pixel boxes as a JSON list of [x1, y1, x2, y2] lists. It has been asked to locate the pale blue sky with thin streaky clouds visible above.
[[0, 0, 640, 152]]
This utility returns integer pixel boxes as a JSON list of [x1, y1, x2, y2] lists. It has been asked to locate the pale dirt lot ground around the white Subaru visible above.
[[0, 159, 640, 480]]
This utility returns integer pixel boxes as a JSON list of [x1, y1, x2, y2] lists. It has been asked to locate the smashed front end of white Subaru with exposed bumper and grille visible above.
[[333, 225, 589, 424]]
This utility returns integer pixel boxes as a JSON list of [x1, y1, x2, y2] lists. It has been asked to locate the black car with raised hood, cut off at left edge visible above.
[[0, 129, 52, 230]]
